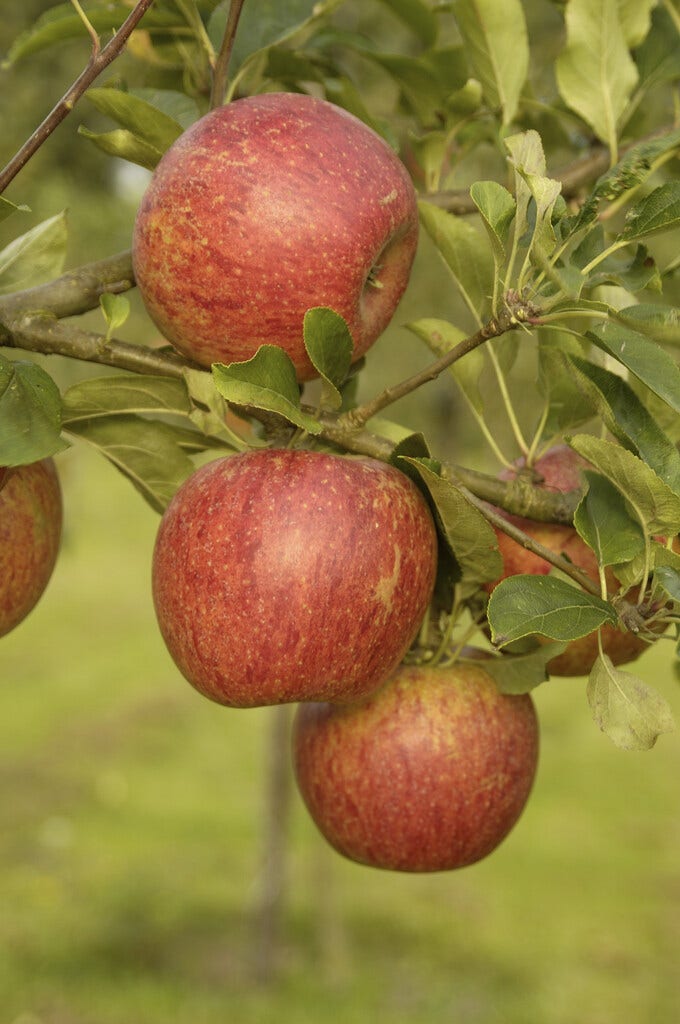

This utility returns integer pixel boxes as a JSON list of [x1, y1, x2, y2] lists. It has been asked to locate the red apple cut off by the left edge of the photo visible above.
[[0, 459, 62, 637]]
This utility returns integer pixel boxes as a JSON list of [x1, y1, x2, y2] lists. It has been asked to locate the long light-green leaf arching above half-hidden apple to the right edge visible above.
[[567, 434, 680, 537]]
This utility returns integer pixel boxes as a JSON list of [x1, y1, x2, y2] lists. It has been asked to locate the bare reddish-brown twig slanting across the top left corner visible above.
[[0, 0, 154, 194]]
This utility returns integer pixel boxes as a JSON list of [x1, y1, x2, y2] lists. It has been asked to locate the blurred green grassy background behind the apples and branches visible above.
[[0, 0, 680, 1024]]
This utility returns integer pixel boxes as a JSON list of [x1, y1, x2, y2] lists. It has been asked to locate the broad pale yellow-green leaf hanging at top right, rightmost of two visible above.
[[556, 0, 638, 151]]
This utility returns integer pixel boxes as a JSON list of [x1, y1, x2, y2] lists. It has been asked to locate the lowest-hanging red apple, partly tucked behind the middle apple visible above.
[[292, 665, 539, 871]]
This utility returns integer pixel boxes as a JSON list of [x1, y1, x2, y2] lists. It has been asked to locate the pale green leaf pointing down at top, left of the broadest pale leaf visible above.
[[453, 0, 529, 125]]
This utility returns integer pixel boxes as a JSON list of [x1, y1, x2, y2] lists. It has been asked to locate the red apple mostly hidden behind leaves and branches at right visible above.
[[487, 444, 649, 676]]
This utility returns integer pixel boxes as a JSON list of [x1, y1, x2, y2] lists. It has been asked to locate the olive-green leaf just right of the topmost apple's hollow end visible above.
[[418, 202, 494, 324]]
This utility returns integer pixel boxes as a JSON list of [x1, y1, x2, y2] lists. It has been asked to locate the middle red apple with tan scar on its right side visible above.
[[153, 449, 437, 708]]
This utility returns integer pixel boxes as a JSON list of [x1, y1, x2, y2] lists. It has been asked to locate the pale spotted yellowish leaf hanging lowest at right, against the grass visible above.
[[587, 654, 675, 751]]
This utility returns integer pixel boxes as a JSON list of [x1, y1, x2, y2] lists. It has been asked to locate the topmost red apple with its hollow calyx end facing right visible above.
[[132, 92, 418, 380]]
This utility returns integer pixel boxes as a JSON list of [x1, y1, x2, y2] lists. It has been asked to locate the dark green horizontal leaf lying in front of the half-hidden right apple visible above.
[[486, 574, 618, 647]]
